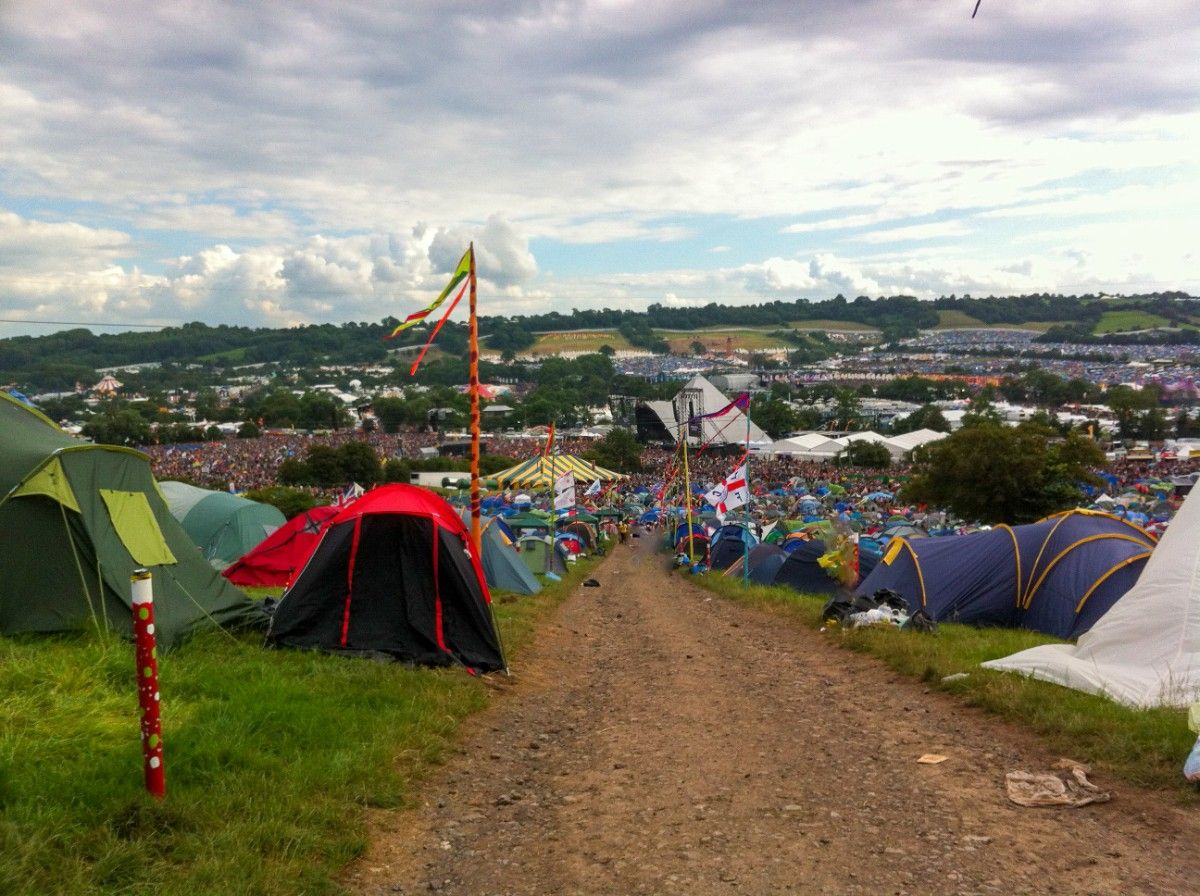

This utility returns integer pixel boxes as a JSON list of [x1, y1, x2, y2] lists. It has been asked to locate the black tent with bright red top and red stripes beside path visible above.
[[266, 485, 504, 672]]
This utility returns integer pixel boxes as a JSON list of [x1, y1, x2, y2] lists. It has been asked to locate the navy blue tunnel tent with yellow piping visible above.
[[858, 510, 1154, 638]]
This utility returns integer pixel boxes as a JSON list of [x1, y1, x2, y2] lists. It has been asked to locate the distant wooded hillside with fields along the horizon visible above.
[[0, 293, 1200, 390]]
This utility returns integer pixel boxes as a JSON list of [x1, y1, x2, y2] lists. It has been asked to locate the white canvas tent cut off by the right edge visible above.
[[984, 492, 1200, 708]]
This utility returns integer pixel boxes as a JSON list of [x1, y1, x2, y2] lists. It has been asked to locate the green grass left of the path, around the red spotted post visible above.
[[0, 561, 593, 896]]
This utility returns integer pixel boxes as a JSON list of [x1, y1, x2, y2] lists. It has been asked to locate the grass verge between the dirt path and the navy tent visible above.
[[698, 575, 1200, 804]]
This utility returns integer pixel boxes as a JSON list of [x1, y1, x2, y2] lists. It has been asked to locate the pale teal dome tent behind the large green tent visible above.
[[158, 482, 287, 567]]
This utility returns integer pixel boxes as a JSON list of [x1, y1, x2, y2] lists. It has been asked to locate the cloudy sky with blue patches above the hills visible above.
[[0, 0, 1200, 337]]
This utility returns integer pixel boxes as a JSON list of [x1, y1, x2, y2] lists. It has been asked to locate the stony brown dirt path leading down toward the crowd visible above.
[[346, 537, 1200, 896]]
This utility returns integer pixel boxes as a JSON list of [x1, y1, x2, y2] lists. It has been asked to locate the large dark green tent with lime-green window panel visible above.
[[0, 393, 265, 647]]
